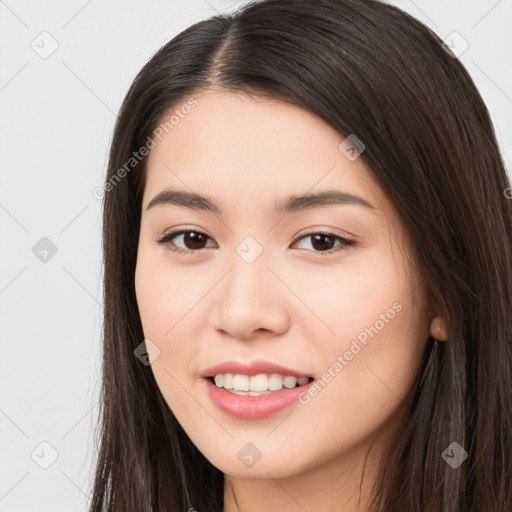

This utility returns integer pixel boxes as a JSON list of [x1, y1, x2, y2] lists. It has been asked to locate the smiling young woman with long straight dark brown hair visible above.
[[90, 0, 512, 512]]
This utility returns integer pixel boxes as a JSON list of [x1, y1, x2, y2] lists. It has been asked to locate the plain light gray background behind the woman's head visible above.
[[0, 0, 512, 512]]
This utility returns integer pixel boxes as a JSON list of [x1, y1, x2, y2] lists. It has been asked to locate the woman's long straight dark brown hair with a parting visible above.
[[90, 0, 512, 512]]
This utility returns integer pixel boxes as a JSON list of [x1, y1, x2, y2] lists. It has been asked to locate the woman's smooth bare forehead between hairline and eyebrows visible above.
[[143, 91, 386, 218]]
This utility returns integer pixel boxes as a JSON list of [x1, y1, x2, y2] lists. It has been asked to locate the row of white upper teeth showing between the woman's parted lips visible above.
[[206, 373, 314, 396]]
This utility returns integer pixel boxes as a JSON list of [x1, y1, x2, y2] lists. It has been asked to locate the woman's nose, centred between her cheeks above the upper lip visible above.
[[214, 248, 291, 340]]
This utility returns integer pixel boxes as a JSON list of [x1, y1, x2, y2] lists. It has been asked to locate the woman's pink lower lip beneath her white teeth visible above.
[[204, 379, 315, 420]]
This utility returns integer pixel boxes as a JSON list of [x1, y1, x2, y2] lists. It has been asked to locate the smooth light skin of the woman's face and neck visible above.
[[135, 90, 447, 512]]
